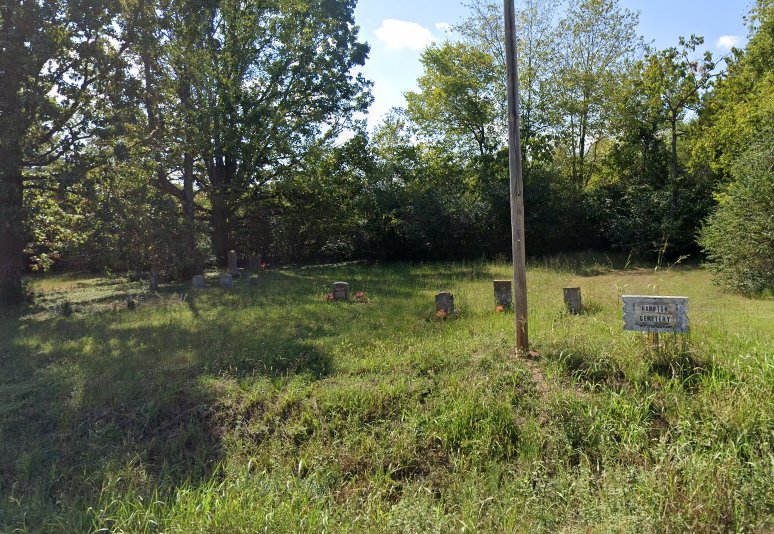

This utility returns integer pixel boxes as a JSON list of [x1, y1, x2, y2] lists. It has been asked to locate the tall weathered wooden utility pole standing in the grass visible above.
[[504, 0, 529, 354]]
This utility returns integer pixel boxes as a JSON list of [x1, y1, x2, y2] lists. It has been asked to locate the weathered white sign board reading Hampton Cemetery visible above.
[[621, 295, 688, 333]]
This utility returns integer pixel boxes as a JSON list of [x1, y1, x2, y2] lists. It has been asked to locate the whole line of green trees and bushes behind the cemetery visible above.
[[0, 0, 774, 302]]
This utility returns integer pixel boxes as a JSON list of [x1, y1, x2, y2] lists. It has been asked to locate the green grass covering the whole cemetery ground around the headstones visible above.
[[0, 256, 774, 532]]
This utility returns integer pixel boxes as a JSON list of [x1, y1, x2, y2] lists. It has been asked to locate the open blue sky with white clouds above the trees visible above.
[[355, 0, 751, 126]]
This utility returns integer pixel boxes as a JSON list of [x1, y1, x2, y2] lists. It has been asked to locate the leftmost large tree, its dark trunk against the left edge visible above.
[[0, 0, 131, 303]]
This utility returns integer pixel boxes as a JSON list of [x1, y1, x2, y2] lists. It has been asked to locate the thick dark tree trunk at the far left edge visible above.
[[0, 162, 24, 304]]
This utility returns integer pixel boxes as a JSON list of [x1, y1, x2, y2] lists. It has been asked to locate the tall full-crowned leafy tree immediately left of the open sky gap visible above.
[[186, 0, 370, 263]]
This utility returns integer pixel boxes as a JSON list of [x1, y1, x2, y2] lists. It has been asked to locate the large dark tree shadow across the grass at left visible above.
[[0, 298, 331, 530]]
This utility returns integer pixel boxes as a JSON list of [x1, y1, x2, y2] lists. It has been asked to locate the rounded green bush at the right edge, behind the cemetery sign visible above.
[[699, 132, 774, 293]]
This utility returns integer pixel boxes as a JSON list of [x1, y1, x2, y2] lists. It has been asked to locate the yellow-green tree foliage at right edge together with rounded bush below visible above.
[[694, 0, 774, 293]]
